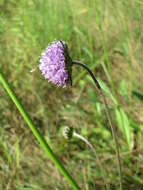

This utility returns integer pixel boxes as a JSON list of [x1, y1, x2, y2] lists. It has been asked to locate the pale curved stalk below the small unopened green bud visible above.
[[73, 132, 110, 190]]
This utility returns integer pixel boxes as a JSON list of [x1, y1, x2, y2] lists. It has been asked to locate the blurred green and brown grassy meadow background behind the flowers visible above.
[[0, 0, 143, 190]]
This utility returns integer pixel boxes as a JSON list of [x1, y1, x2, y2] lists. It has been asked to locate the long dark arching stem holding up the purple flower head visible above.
[[72, 61, 123, 190]]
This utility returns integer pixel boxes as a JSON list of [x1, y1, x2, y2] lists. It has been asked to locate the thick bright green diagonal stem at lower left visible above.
[[0, 70, 80, 190]]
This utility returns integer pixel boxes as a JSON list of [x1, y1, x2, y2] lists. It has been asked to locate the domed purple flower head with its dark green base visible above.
[[39, 41, 72, 87]]
